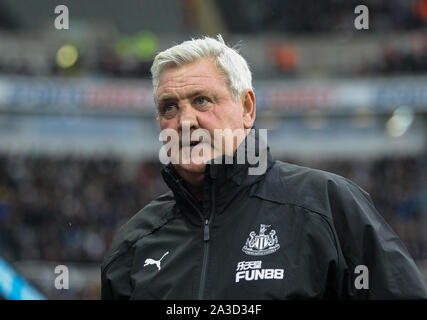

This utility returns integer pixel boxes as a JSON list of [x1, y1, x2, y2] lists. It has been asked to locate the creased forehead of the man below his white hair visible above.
[[156, 59, 229, 99]]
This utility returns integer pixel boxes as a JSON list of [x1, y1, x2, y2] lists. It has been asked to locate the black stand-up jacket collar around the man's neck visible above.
[[161, 127, 273, 221]]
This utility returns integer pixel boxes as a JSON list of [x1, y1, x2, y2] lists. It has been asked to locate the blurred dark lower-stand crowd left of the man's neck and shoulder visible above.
[[0, 156, 166, 262]]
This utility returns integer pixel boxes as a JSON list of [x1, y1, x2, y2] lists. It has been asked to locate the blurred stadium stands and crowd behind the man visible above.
[[0, 0, 427, 299]]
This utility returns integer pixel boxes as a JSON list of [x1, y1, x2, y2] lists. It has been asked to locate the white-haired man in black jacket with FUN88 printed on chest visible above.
[[102, 36, 427, 299]]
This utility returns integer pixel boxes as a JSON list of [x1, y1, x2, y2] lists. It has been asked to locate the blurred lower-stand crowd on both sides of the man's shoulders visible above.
[[0, 156, 427, 262]]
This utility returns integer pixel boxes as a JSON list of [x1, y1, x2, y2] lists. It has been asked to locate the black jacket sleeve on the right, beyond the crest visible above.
[[328, 179, 427, 299]]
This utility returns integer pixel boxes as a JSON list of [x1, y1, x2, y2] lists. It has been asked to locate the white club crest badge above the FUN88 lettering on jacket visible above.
[[242, 224, 280, 256]]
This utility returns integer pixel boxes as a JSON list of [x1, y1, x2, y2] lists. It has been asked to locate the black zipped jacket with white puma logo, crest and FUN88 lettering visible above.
[[101, 132, 427, 299]]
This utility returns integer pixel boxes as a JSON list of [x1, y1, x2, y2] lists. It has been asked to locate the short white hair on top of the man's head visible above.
[[151, 34, 253, 101]]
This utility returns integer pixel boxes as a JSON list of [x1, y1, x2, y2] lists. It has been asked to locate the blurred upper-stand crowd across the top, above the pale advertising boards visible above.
[[0, 0, 427, 79]]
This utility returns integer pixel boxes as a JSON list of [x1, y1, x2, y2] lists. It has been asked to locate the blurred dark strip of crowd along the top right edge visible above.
[[218, 0, 427, 34]]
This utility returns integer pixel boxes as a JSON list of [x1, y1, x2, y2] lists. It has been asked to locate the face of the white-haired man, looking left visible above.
[[156, 58, 251, 185]]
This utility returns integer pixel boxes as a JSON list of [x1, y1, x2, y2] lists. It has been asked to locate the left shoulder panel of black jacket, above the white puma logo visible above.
[[102, 191, 175, 267]]
